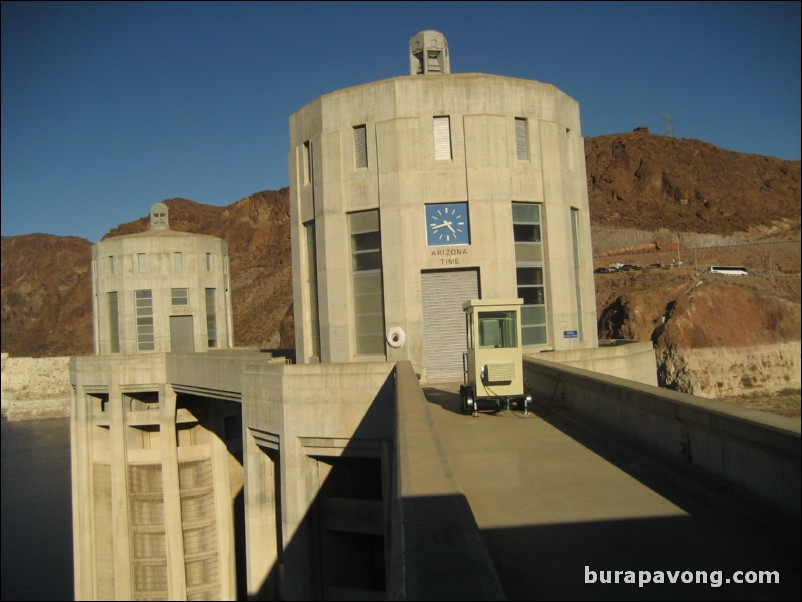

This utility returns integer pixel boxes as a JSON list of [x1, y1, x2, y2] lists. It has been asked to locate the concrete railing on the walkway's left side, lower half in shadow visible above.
[[387, 361, 506, 600]]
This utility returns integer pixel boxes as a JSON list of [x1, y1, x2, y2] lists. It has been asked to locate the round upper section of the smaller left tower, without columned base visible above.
[[92, 203, 233, 355]]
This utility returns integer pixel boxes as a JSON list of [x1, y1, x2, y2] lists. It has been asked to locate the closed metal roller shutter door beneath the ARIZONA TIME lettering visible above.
[[421, 270, 479, 382]]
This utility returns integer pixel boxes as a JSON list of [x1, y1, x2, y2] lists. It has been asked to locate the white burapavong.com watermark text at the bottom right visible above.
[[585, 565, 780, 587]]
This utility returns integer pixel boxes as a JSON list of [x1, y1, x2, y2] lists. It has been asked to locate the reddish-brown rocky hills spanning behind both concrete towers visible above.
[[2, 129, 800, 404]]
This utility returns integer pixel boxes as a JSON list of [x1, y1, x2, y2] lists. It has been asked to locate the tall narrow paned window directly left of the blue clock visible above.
[[348, 209, 384, 355]]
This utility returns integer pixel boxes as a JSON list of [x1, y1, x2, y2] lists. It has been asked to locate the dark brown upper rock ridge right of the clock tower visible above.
[[585, 131, 800, 234]]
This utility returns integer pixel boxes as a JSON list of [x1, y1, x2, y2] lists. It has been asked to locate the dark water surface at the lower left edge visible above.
[[0, 418, 73, 600]]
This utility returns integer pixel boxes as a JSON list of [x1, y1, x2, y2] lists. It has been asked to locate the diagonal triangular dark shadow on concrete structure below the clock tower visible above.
[[247, 371, 395, 600]]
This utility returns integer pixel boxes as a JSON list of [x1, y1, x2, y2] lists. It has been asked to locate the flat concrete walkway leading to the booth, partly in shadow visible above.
[[425, 384, 800, 600]]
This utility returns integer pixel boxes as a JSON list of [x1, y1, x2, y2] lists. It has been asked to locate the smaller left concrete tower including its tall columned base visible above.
[[70, 203, 242, 600]]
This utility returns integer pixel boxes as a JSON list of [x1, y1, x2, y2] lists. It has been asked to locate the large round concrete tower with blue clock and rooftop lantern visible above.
[[289, 30, 598, 382]]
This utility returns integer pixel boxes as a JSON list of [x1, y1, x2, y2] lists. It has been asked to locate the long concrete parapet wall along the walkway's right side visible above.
[[524, 358, 802, 516]]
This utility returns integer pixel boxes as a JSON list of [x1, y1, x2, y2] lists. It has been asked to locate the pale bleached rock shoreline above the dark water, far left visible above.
[[2, 353, 70, 421]]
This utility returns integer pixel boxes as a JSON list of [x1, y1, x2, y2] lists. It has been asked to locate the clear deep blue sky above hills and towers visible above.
[[0, 1, 802, 242]]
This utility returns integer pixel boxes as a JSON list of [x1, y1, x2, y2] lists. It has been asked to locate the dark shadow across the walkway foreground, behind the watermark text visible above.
[[482, 516, 800, 600]]
